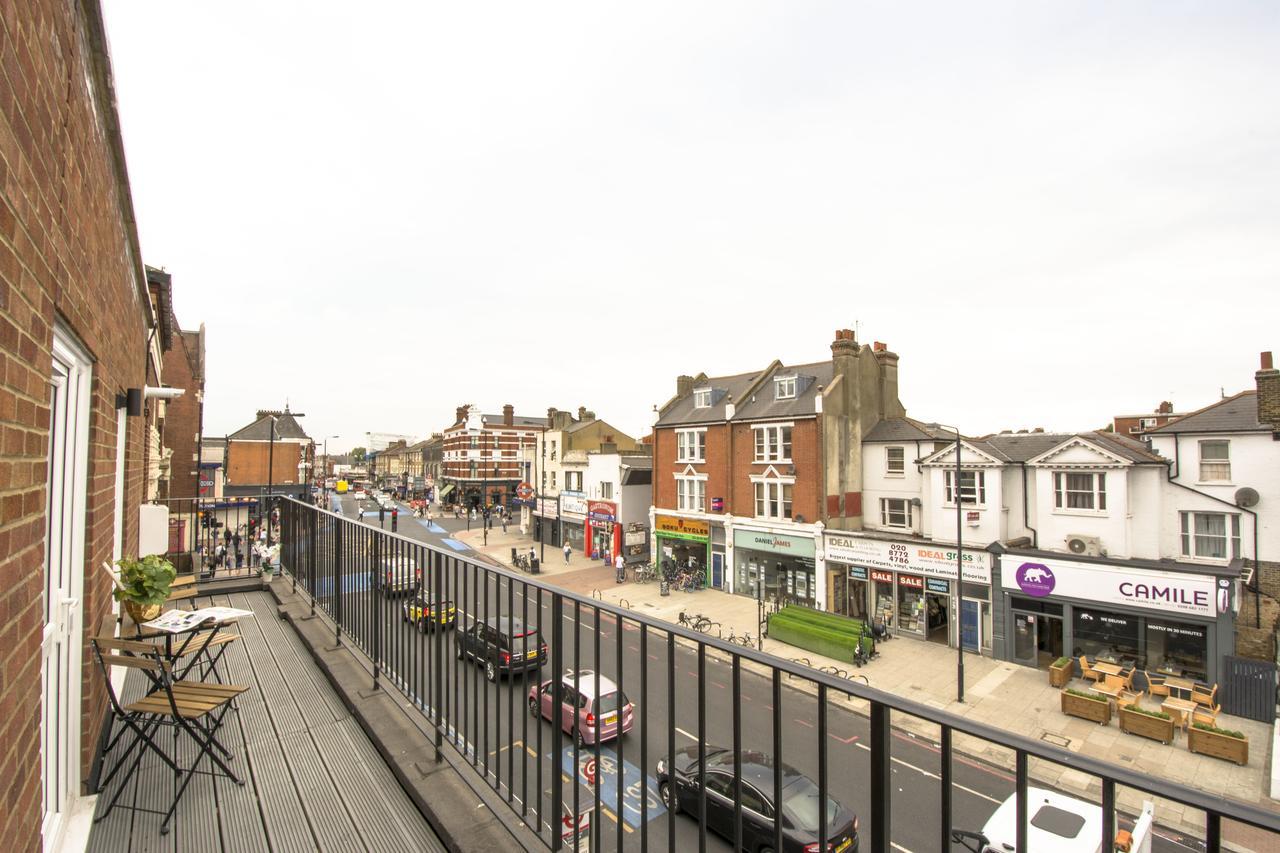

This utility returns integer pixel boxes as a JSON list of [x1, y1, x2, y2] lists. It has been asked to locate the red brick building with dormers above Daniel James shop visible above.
[[652, 329, 905, 603]]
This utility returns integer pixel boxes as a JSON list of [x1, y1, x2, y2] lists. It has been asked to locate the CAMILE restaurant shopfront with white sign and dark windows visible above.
[[1001, 555, 1238, 681]]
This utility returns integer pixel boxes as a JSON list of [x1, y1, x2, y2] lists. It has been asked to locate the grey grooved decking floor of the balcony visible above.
[[88, 592, 444, 853]]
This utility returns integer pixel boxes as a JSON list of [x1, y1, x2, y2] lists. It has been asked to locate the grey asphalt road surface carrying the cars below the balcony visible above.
[[317, 498, 1203, 852]]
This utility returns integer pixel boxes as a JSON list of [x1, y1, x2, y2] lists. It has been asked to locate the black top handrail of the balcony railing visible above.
[[274, 494, 1280, 833]]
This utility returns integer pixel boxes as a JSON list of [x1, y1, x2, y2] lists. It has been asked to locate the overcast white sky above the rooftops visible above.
[[105, 0, 1280, 450]]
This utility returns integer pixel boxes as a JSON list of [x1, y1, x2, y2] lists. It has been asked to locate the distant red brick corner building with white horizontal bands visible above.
[[440, 403, 547, 507]]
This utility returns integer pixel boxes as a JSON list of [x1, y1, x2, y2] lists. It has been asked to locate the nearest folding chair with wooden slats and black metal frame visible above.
[[91, 637, 248, 835]]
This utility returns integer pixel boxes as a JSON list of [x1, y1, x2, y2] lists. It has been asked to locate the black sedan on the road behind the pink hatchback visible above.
[[657, 744, 858, 853]]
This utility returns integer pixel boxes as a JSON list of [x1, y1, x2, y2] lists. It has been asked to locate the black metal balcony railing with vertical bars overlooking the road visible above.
[[278, 498, 1280, 853]]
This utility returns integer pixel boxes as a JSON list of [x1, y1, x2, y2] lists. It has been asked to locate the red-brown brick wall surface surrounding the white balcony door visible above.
[[0, 0, 157, 850]]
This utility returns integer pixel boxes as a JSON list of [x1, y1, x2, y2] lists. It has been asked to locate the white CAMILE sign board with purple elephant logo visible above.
[[1001, 555, 1215, 617]]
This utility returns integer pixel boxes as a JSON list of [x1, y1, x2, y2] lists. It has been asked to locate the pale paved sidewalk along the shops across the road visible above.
[[454, 517, 1280, 850]]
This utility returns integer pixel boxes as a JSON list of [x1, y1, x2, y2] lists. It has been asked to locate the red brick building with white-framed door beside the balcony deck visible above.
[[0, 0, 163, 850]]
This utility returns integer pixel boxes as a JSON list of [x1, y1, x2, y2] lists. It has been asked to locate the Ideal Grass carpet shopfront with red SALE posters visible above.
[[823, 533, 992, 651]]
